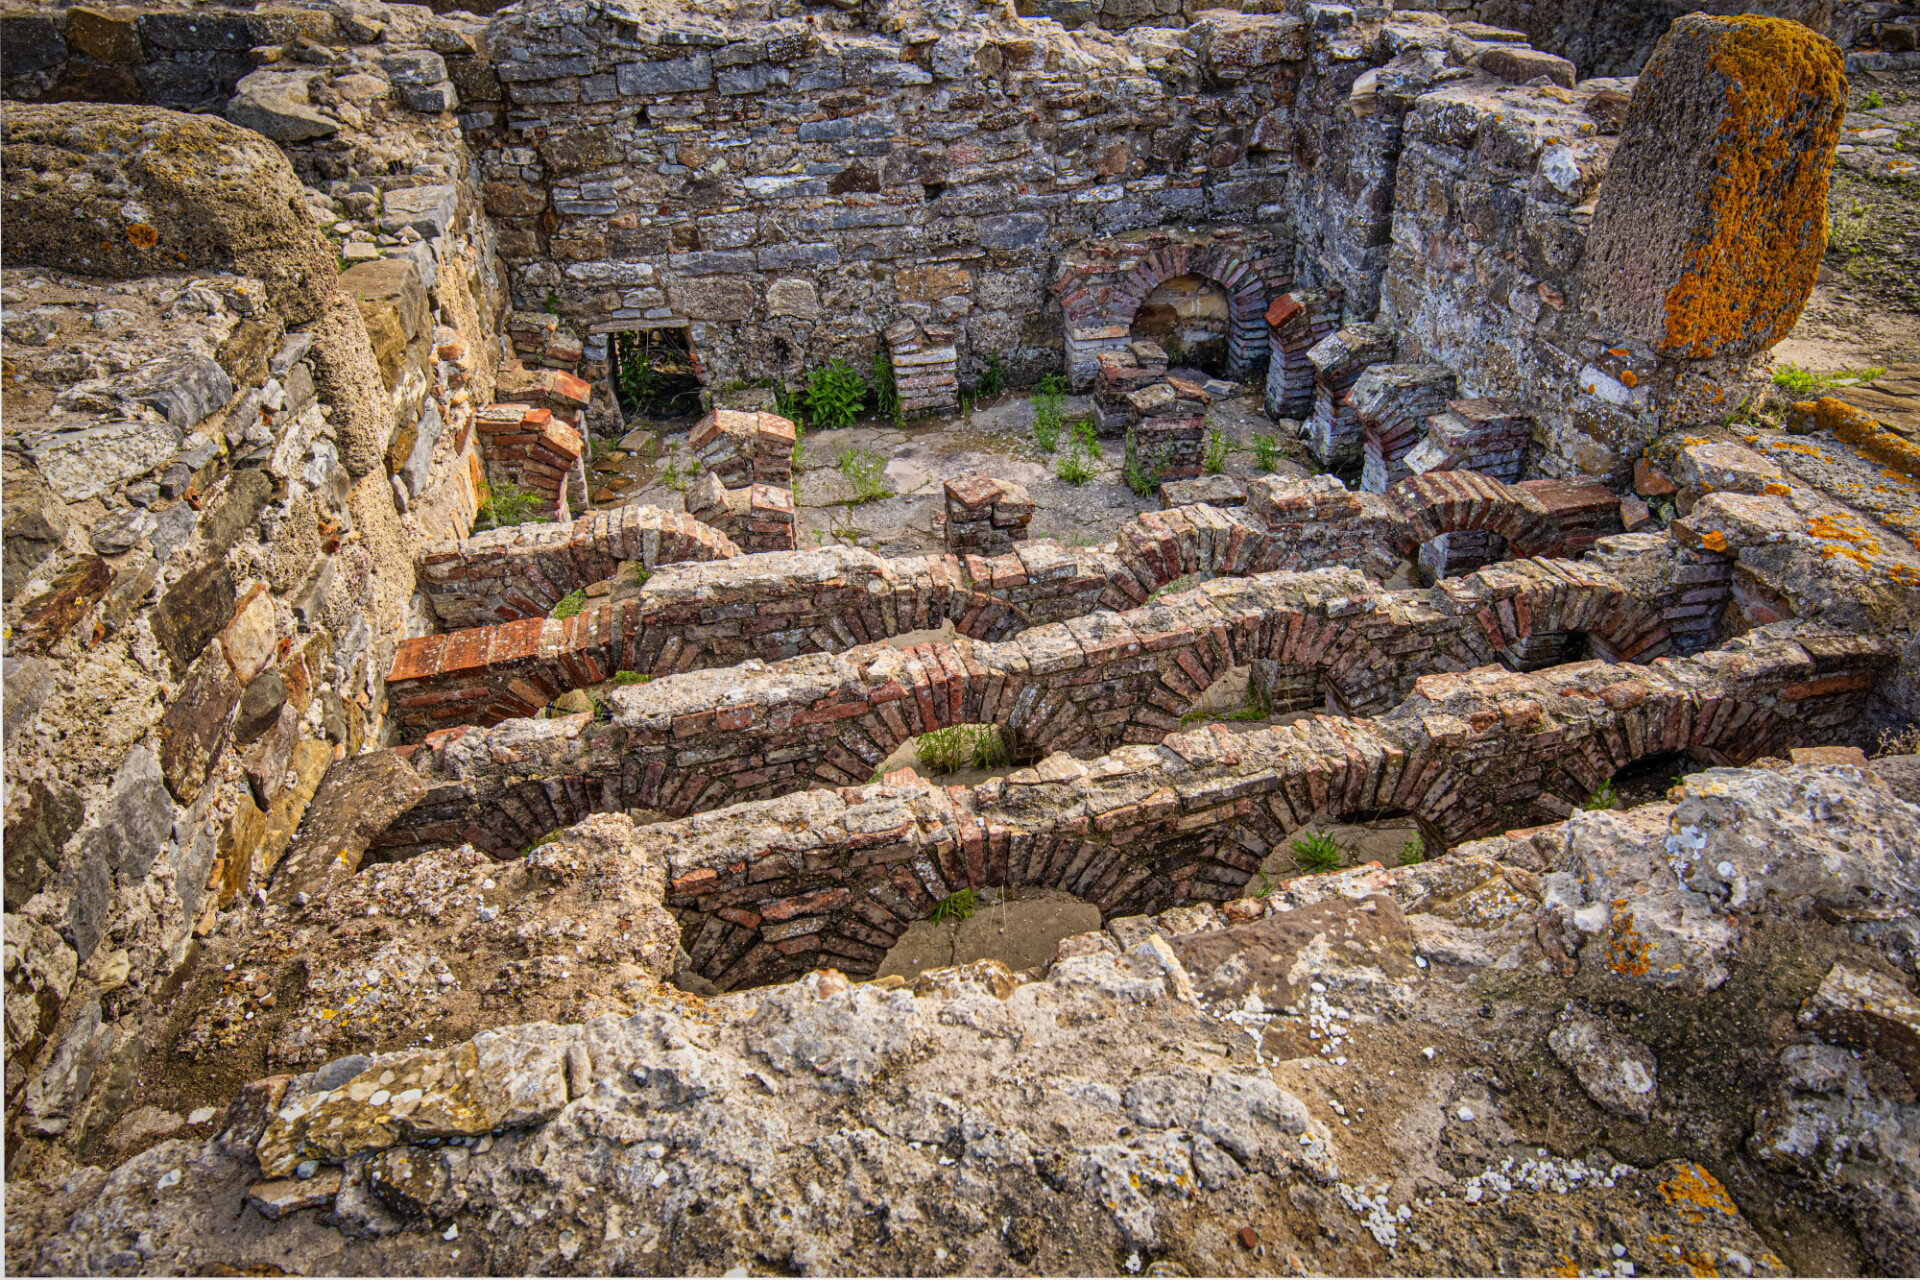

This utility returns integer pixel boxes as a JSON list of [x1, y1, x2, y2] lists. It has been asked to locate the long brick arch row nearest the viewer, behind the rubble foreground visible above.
[[401, 624, 1891, 988]]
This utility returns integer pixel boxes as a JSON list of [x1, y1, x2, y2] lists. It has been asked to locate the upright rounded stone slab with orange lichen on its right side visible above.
[[1582, 13, 1847, 359]]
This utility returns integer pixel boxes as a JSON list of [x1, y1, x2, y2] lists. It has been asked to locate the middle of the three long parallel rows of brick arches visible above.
[[376, 560, 1712, 856]]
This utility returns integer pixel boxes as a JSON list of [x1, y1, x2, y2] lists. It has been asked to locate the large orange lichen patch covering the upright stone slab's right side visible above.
[[1661, 15, 1847, 359]]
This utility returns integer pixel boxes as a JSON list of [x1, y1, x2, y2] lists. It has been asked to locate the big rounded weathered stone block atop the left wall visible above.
[[4, 104, 336, 324]]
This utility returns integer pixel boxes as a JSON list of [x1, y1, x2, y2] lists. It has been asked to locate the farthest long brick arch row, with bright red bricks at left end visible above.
[[388, 472, 1635, 741]]
